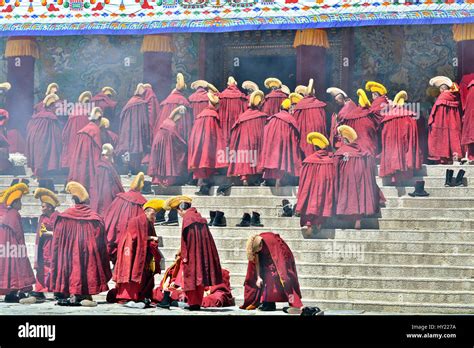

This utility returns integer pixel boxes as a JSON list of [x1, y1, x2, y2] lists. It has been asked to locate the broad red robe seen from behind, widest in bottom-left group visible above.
[[50, 204, 112, 295]]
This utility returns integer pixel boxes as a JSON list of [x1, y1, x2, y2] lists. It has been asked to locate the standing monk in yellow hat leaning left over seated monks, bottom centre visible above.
[[165, 196, 222, 311]]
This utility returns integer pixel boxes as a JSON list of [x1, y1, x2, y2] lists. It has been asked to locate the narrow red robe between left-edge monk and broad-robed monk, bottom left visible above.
[[35, 211, 59, 292]]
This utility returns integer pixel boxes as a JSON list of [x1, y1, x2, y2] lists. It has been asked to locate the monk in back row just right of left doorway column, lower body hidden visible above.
[[153, 73, 193, 140]]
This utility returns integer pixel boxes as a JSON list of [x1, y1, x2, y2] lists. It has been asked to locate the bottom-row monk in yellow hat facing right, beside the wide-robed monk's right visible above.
[[107, 199, 164, 303]]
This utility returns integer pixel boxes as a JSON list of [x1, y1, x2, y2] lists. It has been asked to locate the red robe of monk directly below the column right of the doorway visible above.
[[293, 95, 327, 157]]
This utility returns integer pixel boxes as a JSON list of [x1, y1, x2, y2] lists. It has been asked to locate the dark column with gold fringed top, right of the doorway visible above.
[[293, 29, 329, 99]]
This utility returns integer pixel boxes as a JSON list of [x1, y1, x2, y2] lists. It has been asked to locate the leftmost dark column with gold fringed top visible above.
[[5, 37, 39, 153]]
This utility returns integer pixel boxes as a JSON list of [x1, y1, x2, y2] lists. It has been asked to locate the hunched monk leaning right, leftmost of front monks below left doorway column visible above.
[[148, 105, 188, 187]]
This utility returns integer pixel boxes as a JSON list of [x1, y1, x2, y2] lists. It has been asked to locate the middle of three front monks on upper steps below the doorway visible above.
[[227, 90, 268, 186]]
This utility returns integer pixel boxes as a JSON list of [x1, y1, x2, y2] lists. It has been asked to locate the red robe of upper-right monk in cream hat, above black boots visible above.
[[428, 91, 463, 163]]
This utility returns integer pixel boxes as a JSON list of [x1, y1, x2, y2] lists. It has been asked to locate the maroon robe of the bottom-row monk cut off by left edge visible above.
[[0, 204, 35, 295]]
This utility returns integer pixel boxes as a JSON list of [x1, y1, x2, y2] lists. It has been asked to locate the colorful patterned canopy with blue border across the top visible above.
[[0, 0, 474, 36]]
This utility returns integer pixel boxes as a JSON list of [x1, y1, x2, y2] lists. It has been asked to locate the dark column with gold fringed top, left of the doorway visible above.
[[141, 35, 173, 100]]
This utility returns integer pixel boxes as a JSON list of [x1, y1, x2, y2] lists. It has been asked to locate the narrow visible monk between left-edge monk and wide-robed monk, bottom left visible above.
[[32, 187, 60, 299]]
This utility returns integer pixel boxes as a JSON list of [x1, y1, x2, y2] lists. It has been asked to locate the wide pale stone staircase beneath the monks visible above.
[[0, 165, 474, 314]]
